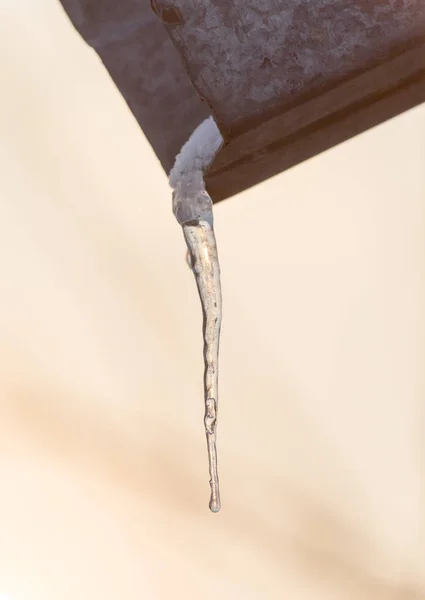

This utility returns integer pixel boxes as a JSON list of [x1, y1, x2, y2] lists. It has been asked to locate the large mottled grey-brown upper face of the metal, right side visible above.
[[152, 0, 425, 138]]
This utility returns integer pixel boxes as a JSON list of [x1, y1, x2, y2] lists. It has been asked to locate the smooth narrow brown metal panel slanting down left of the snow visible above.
[[61, 0, 210, 173]]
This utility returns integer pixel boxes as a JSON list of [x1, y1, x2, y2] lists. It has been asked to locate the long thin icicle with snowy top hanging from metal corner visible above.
[[170, 117, 223, 512]]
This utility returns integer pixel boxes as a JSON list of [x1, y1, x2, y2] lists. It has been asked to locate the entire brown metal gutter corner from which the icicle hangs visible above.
[[61, 0, 425, 202]]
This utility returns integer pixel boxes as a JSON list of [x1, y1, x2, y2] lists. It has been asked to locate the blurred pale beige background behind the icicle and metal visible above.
[[0, 0, 425, 600]]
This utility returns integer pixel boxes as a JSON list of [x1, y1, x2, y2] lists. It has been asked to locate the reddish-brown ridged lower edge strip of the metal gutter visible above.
[[206, 45, 425, 202]]
